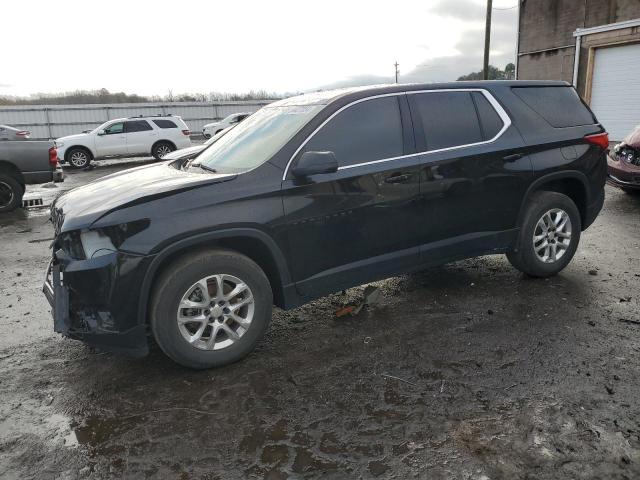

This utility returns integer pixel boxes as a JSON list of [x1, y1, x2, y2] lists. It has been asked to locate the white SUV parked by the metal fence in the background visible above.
[[56, 115, 191, 168]]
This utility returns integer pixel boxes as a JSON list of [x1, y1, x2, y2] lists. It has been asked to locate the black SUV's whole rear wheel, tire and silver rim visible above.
[[507, 192, 582, 278]]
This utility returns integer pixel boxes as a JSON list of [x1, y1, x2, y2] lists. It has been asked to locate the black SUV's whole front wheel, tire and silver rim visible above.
[[150, 250, 273, 369]]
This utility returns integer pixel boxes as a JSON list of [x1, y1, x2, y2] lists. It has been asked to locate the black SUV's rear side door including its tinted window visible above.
[[407, 90, 531, 260]]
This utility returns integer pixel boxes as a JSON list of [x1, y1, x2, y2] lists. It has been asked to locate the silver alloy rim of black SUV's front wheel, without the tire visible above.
[[177, 274, 255, 350]]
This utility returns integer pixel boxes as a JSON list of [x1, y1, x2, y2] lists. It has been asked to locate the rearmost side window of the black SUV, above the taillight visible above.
[[511, 87, 597, 128]]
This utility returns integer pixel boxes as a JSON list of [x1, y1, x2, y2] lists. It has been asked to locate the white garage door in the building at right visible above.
[[591, 44, 640, 140]]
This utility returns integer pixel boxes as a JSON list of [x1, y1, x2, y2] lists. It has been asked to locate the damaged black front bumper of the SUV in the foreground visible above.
[[43, 250, 152, 356]]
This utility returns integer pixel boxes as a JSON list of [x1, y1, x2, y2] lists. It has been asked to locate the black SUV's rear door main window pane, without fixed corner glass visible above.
[[407, 92, 483, 151]]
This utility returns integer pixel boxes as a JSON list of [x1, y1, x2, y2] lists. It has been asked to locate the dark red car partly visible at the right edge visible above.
[[607, 125, 640, 193]]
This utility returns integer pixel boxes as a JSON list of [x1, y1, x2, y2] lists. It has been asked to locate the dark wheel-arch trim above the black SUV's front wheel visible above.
[[138, 228, 291, 323]]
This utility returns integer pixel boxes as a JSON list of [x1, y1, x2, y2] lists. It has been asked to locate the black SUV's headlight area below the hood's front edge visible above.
[[56, 219, 149, 260]]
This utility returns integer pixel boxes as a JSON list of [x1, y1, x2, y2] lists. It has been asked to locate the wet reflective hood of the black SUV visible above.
[[51, 163, 237, 235]]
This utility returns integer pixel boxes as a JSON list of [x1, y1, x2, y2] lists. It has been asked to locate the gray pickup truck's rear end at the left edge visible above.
[[0, 140, 64, 213]]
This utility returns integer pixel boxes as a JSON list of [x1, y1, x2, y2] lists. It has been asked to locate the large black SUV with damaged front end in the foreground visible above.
[[44, 81, 608, 368]]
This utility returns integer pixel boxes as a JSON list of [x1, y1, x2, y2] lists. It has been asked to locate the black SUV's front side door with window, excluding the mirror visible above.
[[283, 94, 419, 296]]
